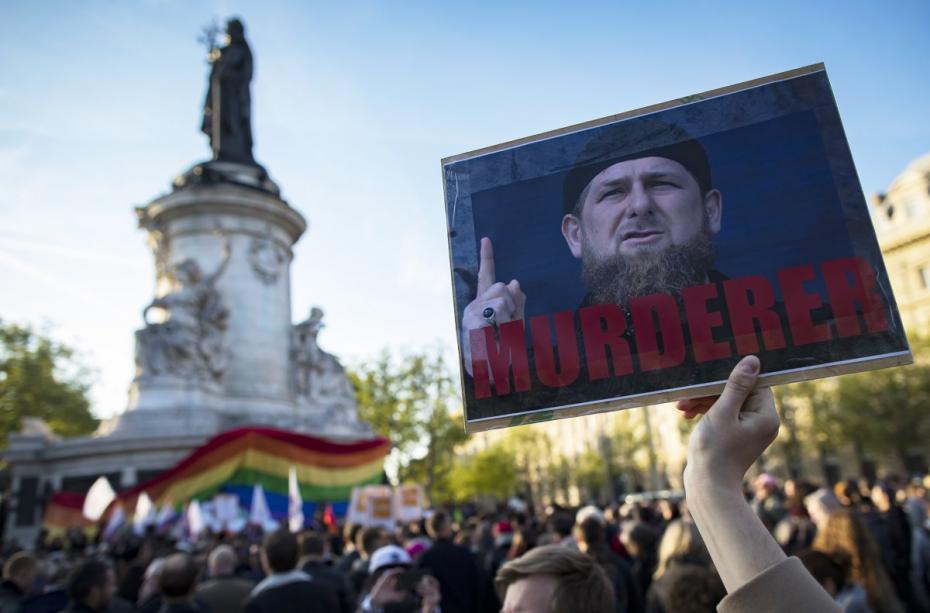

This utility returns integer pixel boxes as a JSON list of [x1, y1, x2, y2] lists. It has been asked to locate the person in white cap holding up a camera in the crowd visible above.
[[359, 545, 442, 613]]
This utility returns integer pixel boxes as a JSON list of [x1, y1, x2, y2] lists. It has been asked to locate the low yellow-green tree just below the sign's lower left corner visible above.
[[450, 442, 519, 501]]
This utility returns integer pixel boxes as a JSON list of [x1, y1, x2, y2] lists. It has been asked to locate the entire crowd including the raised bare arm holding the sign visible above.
[[0, 356, 930, 613]]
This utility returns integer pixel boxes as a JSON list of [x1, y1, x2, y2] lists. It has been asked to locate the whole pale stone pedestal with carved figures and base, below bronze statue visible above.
[[2, 162, 371, 544]]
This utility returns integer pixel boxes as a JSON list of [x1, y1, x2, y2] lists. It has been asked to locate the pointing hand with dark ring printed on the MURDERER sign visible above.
[[462, 237, 526, 375]]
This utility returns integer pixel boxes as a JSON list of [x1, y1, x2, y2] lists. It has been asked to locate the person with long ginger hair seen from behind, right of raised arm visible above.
[[813, 508, 905, 613]]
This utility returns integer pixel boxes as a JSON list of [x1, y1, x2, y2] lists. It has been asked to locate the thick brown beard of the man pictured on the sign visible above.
[[581, 230, 717, 305]]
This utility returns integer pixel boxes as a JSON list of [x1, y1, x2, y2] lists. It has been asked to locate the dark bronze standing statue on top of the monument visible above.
[[201, 19, 255, 165]]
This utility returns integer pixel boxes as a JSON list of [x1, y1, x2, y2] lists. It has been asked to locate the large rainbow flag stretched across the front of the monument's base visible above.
[[117, 428, 391, 520]]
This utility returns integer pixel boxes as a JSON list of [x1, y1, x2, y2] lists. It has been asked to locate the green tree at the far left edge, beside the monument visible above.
[[0, 321, 98, 446]]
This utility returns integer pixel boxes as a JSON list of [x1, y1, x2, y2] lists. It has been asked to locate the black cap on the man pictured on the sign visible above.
[[562, 117, 712, 215]]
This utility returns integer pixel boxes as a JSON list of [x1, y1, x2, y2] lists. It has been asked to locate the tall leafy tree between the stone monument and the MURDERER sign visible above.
[[349, 349, 466, 499]]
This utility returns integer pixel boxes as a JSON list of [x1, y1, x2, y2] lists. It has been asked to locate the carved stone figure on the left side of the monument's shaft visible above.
[[136, 241, 230, 381]]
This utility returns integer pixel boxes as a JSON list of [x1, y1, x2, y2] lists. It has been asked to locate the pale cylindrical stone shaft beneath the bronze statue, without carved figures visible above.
[[116, 167, 306, 433]]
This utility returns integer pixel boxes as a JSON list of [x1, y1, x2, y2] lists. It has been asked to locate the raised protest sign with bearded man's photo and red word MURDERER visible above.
[[443, 64, 912, 432]]
